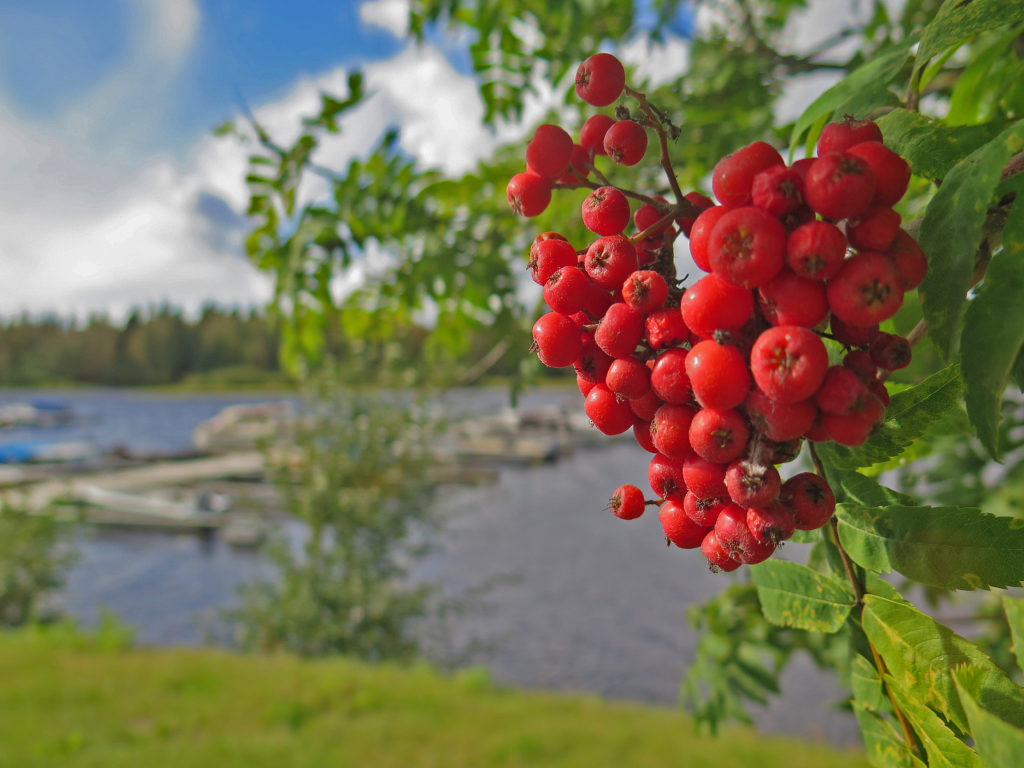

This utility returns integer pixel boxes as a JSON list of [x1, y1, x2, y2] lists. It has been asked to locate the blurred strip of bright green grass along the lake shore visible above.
[[0, 631, 866, 768]]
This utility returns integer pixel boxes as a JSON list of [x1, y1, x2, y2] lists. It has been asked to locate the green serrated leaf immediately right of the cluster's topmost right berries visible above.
[[878, 110, 998, 181]]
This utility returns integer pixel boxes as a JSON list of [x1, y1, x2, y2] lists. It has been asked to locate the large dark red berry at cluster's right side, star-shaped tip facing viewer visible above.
[[827, 251, 903, 326]]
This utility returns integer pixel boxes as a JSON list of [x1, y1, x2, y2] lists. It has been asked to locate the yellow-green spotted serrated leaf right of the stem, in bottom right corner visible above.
[[861, 595, 1024, 732]]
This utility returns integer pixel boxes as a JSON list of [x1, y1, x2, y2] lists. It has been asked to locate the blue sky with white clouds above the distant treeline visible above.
[[0, 0, 864, 316]]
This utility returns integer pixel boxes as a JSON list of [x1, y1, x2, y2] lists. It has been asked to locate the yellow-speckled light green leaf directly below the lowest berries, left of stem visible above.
[[751, 560, 855, 633]]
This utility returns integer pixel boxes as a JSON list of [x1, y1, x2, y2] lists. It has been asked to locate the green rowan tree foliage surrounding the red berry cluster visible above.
[[230, 0, 1024, 766]]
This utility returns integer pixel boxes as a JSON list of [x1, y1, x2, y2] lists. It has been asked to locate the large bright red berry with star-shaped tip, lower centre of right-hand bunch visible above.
[[751, 326, 828, 402]]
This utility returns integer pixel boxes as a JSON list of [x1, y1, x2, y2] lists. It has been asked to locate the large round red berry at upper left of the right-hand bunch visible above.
[[708, 206, 786, 288]]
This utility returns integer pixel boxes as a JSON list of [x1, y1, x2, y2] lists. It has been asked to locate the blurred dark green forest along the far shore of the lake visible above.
[[0, 304, 530, 388]]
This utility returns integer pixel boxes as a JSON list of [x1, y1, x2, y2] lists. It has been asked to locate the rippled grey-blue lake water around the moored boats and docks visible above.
[[0, 390, 857, 744]]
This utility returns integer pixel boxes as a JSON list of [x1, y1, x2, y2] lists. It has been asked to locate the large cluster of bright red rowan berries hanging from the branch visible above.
[[507, 53, 927, 570]]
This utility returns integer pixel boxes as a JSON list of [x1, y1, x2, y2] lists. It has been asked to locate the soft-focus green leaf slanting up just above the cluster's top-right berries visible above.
[[790, 42, 916, 153]]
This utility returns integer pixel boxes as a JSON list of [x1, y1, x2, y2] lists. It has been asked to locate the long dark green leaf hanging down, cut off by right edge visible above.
[[961, 195, 1024, 460]]
